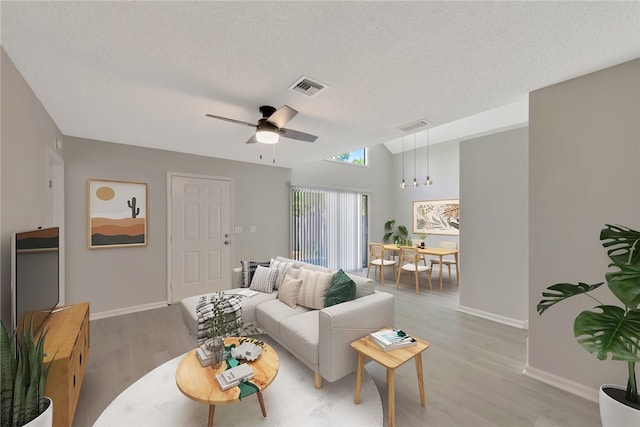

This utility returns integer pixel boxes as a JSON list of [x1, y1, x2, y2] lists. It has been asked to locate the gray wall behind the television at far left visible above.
[[0, 49, 62, 325]]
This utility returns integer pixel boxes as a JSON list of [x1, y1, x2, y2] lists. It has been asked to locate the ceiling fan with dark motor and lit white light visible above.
[[207, 105, 318, 144]]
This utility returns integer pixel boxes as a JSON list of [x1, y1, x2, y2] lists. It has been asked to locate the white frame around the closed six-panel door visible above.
[[167, 171, 235, 305]]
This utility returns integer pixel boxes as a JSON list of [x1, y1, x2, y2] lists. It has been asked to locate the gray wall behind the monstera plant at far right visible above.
[[527, 59, 640, 397]]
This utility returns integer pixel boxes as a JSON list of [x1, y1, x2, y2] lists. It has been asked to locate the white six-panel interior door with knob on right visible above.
[[168, 174, 231, 303]]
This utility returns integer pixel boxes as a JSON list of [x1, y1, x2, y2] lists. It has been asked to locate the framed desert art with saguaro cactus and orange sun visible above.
[[87, 179, 147, 249]]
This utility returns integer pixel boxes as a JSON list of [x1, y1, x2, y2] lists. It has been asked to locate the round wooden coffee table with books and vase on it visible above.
[[176, 337, 280, 427]]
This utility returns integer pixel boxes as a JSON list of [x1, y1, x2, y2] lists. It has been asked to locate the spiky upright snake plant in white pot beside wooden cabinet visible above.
[[0, 323, 53, 427]]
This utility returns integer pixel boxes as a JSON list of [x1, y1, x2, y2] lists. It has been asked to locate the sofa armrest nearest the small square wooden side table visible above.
[[318, 291, 395, 382]]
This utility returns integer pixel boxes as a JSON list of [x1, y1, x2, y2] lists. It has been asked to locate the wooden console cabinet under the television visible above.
[[44, 303, 89, 427]]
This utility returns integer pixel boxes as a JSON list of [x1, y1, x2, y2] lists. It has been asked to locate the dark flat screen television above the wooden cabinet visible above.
[[11, 227, 60, 334]]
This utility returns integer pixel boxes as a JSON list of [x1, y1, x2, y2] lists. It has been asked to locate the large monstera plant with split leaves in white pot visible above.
[[537, 224, 640, 427]]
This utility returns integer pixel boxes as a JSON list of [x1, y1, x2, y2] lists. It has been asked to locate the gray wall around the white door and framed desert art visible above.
[[64, 137, 289, 314]]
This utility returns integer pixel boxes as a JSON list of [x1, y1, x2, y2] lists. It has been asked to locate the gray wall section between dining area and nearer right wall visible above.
[[460, 127, 529, 328]]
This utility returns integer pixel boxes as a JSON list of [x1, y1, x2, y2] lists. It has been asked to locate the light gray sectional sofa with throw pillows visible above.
[[180, 257, 394, 388]]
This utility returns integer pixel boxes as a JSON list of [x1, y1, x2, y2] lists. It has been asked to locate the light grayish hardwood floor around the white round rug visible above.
[[73, 270, 600, 427]]
